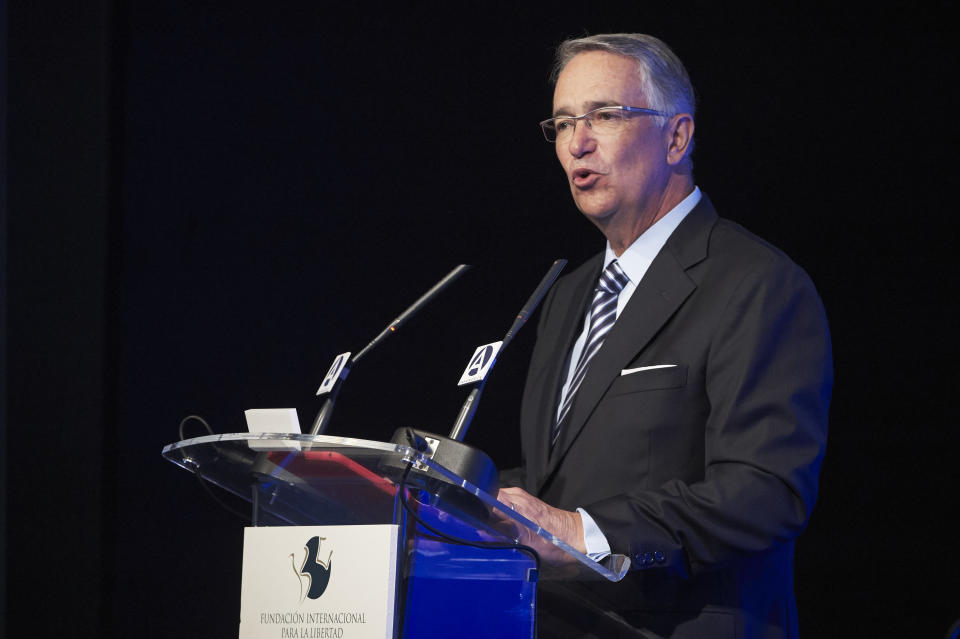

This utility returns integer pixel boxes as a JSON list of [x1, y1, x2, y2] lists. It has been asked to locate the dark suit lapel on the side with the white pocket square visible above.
[[537, 195, 717, 482]]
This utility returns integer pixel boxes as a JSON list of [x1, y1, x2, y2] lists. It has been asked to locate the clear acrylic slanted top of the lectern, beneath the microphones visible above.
[[163, 433, 629, 581]]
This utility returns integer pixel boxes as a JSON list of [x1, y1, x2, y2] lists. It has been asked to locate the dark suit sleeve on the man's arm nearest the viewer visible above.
[[583, 264, 832, 575]]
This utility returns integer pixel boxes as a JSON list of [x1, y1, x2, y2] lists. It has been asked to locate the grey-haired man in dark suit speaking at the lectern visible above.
[[499, 34, 832, 638]]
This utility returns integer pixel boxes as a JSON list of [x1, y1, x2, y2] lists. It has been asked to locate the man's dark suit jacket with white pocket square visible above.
[[521, 196, 832, 638]]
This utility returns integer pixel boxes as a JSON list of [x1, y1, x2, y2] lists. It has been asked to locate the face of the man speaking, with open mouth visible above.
[[553, 51, 669, 230]]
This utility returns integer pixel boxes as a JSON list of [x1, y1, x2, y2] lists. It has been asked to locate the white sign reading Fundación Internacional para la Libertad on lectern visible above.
[[240, 524, 398, 639]]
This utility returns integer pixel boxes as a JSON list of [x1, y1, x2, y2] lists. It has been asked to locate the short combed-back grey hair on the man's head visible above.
[[550, 33, 695, 121]]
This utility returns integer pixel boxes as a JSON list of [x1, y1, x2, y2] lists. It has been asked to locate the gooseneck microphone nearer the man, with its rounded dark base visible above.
[[391, 259, 567, 498]]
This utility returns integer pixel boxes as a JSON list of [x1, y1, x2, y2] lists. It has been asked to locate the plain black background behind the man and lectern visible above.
[[0, 1, 960, 637]]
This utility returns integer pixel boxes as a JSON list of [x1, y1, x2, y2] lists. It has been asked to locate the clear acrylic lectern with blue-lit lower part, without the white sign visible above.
[[163, 433, 629, 639]]
